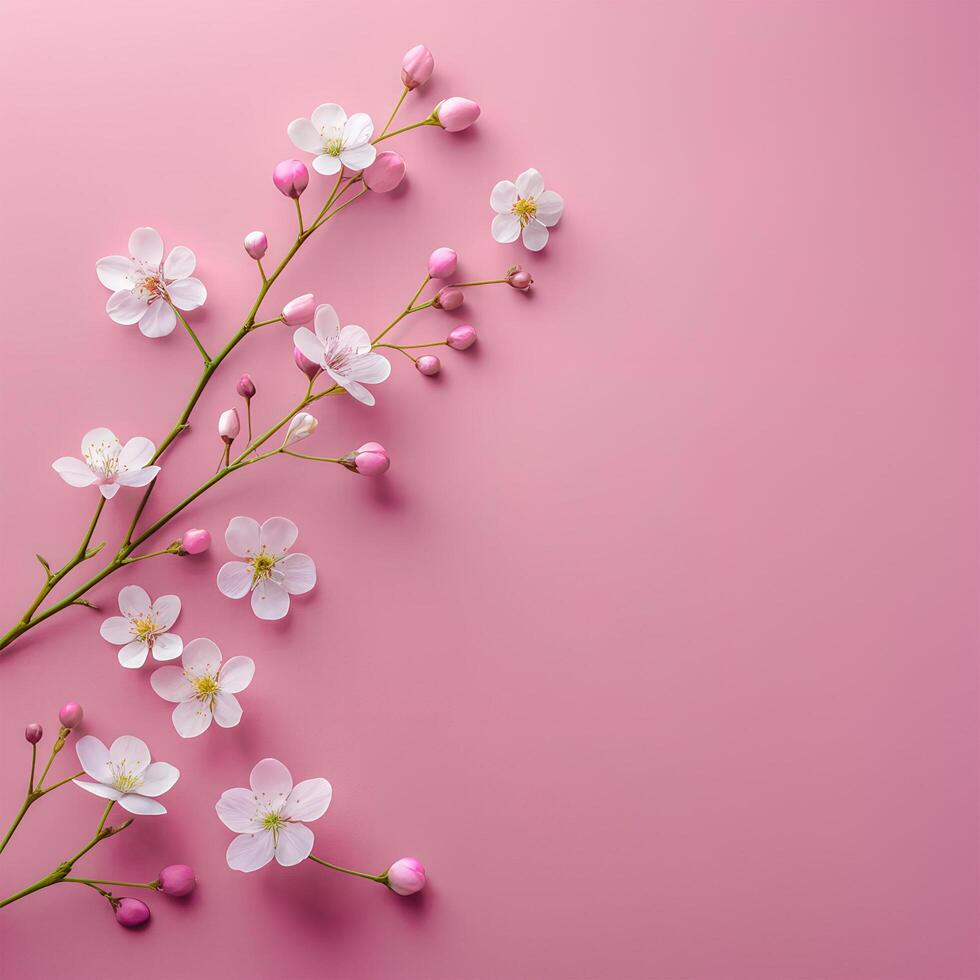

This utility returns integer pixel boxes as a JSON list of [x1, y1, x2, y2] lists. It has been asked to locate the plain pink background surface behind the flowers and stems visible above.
[[0, 0, 978, 980]]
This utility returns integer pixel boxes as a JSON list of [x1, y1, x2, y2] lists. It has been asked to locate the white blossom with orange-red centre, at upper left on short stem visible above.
[[95, 228, 208, 337]]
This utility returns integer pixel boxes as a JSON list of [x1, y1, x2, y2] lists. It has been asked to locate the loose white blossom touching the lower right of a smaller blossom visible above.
[[150, 637, 255, 738]]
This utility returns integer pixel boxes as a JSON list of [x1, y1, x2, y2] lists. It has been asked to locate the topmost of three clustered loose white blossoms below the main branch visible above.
[[218, 517, 316, 619]]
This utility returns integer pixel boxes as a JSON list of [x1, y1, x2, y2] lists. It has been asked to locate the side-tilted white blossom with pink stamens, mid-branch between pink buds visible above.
[[293, 303, 391, 405]]
